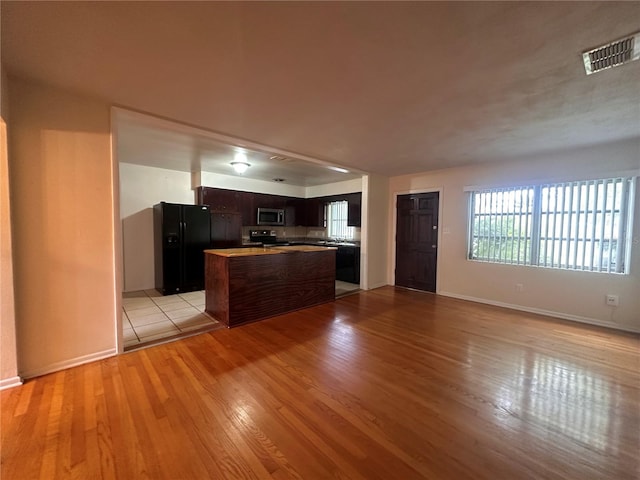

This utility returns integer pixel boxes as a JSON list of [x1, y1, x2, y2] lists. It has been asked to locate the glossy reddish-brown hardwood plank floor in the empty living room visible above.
[[1, 287, 640, 480]]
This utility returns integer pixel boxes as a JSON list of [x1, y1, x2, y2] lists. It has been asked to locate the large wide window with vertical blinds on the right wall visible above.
[[468, 177, 635, 273]]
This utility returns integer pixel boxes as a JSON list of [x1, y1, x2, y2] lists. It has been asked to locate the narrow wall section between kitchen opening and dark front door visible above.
[[361, 174, 389, 290]]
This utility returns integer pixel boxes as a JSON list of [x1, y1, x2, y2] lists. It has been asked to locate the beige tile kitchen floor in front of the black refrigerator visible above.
[[122, 290, 220, 350]]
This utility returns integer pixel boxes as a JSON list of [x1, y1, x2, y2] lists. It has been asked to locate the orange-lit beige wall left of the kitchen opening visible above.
[[9, 79, 118, 377]]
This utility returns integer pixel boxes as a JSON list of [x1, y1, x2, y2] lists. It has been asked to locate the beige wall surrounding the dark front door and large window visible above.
[[388, 140, 640, 331]]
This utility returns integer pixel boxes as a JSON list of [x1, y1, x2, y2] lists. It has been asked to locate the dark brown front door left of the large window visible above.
[[396, 192, 438, 292]]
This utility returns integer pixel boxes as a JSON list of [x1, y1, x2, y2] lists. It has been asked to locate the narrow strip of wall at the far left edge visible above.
[[0, 65, 20, 388]]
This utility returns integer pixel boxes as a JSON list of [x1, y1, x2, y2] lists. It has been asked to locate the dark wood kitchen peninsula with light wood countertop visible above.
[[205, 245, 336, 327]]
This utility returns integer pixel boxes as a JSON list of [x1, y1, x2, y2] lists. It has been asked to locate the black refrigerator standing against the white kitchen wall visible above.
[[153, 202, 211, 295]]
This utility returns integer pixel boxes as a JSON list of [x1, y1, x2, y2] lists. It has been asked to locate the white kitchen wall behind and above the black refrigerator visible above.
[[120, 163, 195, 292]]
